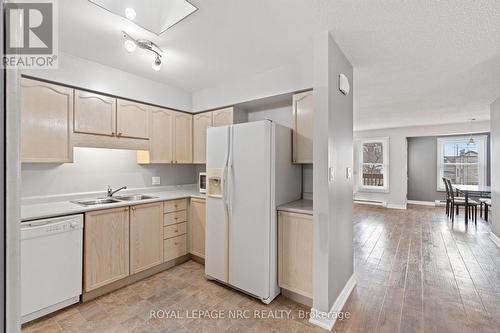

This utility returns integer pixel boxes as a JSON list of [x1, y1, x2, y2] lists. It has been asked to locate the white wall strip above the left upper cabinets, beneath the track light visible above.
[[23, 53, 191, 111]]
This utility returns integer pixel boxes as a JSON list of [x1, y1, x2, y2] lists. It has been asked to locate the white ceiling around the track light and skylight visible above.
[[59, 0, 500, 130]]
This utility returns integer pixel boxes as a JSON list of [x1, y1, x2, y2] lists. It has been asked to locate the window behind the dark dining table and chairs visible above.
[[437, 135, 487, 191]]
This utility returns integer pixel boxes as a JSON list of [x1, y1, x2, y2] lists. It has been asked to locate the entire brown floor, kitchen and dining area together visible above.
[[23, 205, 500, 333]]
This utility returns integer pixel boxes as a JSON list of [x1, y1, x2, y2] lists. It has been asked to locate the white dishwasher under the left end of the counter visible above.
[[21, 214, 83, 323]]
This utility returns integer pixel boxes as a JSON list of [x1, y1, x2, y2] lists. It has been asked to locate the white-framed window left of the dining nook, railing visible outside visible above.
[[358, 138, 389, 192]]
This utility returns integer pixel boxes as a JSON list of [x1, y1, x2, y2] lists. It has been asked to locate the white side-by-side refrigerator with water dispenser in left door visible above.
[[205, 120, 302, 304]]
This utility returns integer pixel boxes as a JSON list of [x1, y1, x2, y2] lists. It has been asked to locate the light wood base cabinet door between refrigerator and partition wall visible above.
[[278, 212, 313, 298]]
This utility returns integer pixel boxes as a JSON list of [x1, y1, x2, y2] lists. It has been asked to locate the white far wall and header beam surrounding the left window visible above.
[[354, 121, 490, 208]]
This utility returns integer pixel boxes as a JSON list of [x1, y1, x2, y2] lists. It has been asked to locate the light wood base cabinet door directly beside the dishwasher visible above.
[[84, 207, 129, 292]]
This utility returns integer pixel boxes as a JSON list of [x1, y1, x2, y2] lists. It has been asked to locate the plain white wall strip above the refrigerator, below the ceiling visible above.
[[192, 48, 313, 112]]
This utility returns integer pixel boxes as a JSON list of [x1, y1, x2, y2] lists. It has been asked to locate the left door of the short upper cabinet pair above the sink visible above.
[[75, 90, 116, 136]]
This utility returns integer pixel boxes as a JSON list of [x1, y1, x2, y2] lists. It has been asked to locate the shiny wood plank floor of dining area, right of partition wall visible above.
[[334, 205, 500, 333]]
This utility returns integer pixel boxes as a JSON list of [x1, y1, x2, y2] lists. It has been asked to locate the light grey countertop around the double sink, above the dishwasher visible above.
[[21, 186, 205, 221]]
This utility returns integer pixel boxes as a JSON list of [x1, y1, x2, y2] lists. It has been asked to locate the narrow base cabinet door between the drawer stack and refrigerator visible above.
[[189, 198, 205, 258]]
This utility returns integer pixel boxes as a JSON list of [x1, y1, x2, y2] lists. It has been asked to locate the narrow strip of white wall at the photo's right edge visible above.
[[490, 98, 500, 239]]
